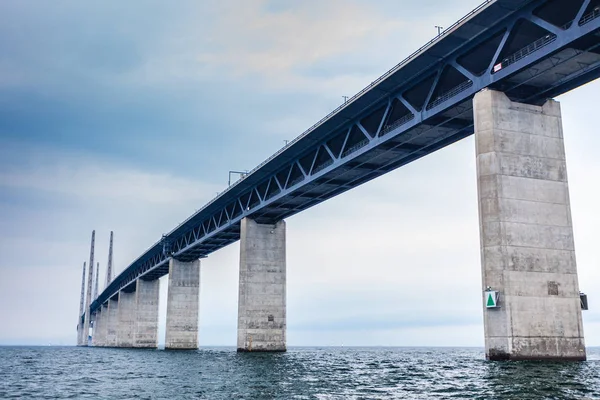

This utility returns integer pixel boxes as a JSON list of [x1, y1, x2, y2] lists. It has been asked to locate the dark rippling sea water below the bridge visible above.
[[0, 347, 600, 400]]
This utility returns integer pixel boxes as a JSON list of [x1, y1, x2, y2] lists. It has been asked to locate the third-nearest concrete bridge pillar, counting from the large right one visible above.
[[165, 259, 200, 350]]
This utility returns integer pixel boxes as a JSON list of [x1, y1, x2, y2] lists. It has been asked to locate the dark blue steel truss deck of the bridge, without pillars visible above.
[[91, 0, 600, 312]]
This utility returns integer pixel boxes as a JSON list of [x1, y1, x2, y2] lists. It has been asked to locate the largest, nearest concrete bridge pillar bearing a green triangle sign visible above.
[[474, 90, 586, 360]]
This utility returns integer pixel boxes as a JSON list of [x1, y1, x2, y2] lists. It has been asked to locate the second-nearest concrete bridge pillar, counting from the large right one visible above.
[[237, 218, 286, 351]]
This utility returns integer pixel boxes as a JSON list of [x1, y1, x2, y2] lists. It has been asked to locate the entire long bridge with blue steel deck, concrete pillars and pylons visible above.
[[78, 0, 600, 360]]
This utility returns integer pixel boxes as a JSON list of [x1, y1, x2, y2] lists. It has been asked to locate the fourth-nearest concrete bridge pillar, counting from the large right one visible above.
[[133, 279, 160, 349]]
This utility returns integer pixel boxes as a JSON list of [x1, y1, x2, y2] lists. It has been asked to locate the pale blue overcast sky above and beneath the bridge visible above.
[[0, 0, 600, 346]]
